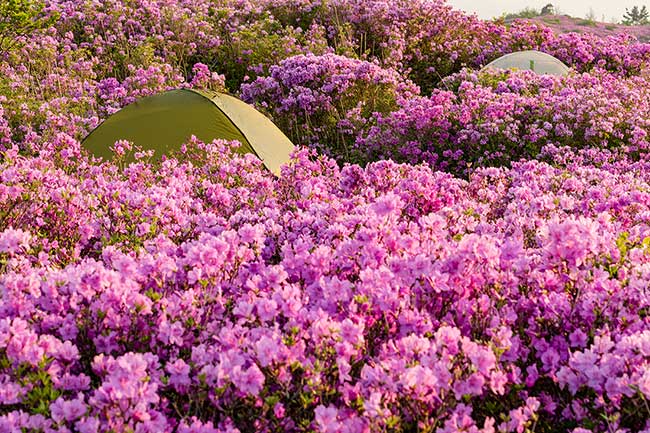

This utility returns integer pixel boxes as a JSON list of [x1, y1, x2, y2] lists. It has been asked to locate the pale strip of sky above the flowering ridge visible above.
[[447, 0, 650, 22]]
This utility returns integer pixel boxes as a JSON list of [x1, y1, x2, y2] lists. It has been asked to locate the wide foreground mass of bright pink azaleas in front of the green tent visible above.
[[0, 142, 650, 432]]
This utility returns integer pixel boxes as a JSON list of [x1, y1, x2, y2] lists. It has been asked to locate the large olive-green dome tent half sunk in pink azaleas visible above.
[[82, 89, 293, 174]]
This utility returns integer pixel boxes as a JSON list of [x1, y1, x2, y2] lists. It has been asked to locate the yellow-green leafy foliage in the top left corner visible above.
[[0, 0, 56, 55]]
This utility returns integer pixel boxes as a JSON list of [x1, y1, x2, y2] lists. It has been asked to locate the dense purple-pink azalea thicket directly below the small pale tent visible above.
[[357, 67, 650, 175]]
